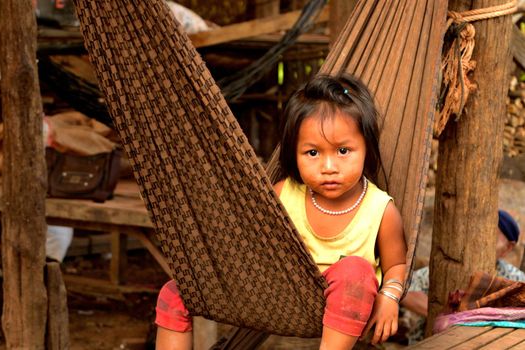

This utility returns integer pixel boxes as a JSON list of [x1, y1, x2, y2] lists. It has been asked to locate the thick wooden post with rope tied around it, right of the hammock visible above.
[[427, 0, 512, 334]]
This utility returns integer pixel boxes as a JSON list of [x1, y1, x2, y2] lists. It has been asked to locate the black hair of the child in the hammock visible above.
[[279, 74, 382, 183]]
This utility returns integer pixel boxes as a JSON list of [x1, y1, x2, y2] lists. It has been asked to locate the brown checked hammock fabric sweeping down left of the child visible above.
[[75, 0, 325, 337]]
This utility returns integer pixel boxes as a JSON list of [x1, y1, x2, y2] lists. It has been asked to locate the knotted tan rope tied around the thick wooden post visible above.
[[434, 0, 518, 137]]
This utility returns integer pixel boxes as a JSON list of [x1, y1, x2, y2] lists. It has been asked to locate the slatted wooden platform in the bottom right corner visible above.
[[408, 326, 525, 350]]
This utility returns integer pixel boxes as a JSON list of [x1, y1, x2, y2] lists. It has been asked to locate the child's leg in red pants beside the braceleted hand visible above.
[[321, 256, 378, 349]]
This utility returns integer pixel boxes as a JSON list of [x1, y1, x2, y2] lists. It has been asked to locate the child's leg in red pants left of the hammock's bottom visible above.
[[155, 280, 193, 350]]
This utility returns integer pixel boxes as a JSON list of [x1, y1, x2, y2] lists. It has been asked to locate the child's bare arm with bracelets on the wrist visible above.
[[363, 202, 407, 344]]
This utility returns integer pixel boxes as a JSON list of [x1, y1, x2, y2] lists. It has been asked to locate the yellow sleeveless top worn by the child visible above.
[[279, 178, 392, 284]]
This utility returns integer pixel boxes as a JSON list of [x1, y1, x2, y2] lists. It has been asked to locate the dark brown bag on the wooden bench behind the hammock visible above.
[[46, 147, 121, 202]]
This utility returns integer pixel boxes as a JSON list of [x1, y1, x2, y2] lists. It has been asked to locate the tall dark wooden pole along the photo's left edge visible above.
[[0, 0, 47, 349]]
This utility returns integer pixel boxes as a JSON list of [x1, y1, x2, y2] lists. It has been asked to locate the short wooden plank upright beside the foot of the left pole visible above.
[[46, 262, 70, 350]]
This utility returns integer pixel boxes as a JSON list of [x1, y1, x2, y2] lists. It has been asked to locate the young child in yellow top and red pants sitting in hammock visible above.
[[156, 76, 406, 350]]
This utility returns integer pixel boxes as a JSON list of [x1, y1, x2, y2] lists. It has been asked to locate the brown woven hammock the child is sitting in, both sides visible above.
[[69, 0, 446, 337]]
